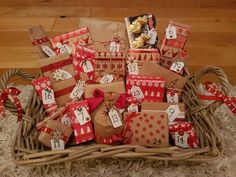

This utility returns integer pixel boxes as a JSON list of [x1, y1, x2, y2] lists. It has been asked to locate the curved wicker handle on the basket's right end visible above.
[[191, 66, 230, 110]]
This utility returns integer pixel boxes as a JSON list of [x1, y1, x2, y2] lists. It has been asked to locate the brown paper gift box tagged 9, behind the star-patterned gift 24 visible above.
[[142, 102, 185, 122]]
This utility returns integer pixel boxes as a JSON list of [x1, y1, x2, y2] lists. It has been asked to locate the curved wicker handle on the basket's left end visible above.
[[0, 68, 35, 91]]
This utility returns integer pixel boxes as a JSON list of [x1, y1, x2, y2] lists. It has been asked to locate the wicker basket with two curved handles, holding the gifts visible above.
[[0, 66, 229, 166]]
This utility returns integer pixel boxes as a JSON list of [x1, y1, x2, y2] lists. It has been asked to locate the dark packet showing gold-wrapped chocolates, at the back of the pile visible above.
[[125, 14, 158, 49]]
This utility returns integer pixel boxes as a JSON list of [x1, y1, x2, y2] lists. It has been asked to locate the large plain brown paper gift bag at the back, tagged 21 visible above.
[[79, 18, 129, 52]]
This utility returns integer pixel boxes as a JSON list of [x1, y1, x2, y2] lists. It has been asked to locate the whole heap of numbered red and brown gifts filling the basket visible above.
[[29, 14, 199, 150]]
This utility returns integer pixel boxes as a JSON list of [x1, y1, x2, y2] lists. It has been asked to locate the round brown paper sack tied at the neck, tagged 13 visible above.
[[93, 92, 123, 144]]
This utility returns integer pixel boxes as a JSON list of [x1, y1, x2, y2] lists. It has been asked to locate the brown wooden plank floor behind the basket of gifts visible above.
[[0, 0, 236, 84]]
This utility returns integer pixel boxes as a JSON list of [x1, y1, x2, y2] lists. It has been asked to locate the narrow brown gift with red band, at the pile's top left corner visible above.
[[29, 25, 56, 58]]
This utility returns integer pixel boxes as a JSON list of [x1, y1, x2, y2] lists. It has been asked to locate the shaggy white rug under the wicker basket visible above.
[[0, 86, 236, 177]]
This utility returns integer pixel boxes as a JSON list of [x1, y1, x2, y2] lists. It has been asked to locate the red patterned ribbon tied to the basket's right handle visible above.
[[199, 81, 236, 115]]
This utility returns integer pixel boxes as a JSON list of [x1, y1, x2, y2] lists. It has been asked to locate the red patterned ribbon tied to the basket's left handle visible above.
[[0, 87, 23, 121]]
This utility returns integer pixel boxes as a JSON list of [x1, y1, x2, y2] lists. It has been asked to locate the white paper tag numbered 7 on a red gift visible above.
[[74, 107, 91, 125]]
